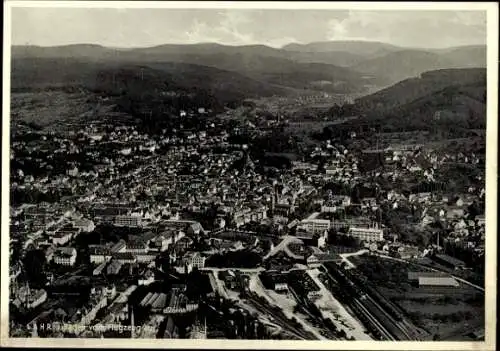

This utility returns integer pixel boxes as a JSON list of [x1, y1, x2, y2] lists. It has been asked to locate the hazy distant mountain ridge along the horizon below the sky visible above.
[[12, 41, 486, 93]]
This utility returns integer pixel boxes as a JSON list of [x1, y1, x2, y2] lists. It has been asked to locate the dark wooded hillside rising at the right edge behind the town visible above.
[[316, 69, 486, 139]]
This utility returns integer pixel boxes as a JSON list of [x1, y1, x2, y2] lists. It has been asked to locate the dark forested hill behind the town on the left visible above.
[[13, 57, 296, 132]]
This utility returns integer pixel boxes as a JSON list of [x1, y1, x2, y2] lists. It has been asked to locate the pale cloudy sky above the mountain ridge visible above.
[[12, 7, 486, 48]]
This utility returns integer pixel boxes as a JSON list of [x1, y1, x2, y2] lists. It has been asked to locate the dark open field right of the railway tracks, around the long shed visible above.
[[349, 254, 485, 340]]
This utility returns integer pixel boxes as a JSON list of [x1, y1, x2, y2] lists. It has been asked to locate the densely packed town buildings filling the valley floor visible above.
[[9, 106, 486, 338]]
